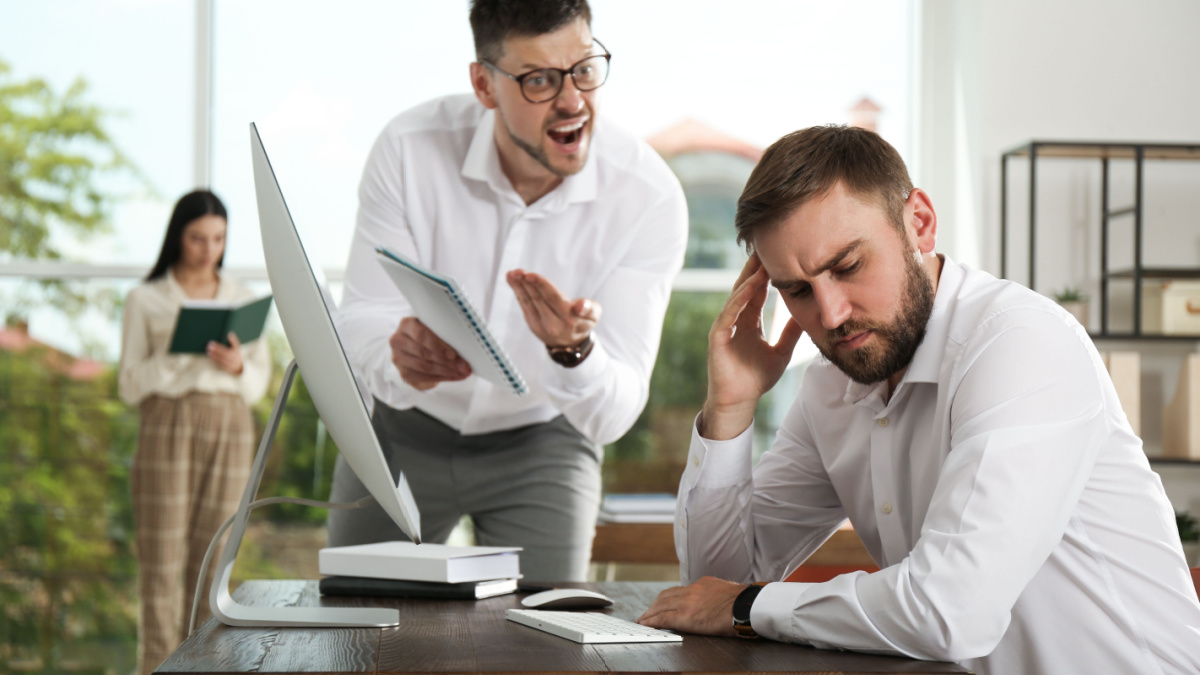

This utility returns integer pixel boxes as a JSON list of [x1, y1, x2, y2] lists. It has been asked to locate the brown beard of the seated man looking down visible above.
[[817, 248, 934, 384]]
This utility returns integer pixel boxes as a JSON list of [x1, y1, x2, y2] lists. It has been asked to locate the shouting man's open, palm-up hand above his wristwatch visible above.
[[506, 269, 600, 347]]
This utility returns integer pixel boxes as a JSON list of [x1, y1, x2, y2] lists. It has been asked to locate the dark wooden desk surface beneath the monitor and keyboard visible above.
[[156, 581, 967, 675]]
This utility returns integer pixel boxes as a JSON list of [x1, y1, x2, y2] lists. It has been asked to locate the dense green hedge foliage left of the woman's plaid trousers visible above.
[[0, 348, 137, 667]]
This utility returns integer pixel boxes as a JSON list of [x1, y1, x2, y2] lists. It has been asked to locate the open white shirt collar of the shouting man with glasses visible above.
[[462, 110, 599, 213]]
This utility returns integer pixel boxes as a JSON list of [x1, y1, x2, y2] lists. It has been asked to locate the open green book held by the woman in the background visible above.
[[170, 295, 274, 354]]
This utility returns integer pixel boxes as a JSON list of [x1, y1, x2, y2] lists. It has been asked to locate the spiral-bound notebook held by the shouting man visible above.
[[376, 249, 529, 396]]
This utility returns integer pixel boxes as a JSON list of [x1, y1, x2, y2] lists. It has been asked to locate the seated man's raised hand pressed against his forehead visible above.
[[700, 256, 804, 441]]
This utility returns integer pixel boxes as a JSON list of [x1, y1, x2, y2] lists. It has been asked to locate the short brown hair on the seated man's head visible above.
[[733, 125, 912, 251]]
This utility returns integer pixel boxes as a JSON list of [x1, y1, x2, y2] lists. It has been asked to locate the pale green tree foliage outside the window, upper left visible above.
[[0, 56, 137, 317]]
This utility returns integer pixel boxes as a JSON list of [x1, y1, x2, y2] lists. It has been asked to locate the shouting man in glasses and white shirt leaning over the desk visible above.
[[329, 0, 688, 580]]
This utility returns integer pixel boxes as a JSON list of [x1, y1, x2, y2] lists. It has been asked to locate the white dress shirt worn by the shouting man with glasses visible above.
[[338, 95, 688, 444]]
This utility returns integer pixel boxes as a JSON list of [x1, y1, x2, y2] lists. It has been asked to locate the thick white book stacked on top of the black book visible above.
[[317, 542, 521, 584]]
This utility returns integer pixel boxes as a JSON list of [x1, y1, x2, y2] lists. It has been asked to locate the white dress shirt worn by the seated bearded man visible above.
[[676, 259, 1200, 675]]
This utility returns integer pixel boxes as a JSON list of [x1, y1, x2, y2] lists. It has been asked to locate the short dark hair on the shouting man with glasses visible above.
[[470, 0, 592, 64]]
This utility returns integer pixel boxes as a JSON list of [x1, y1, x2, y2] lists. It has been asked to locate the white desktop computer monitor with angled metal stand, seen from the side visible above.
[[209, 124, 421, 627]]
